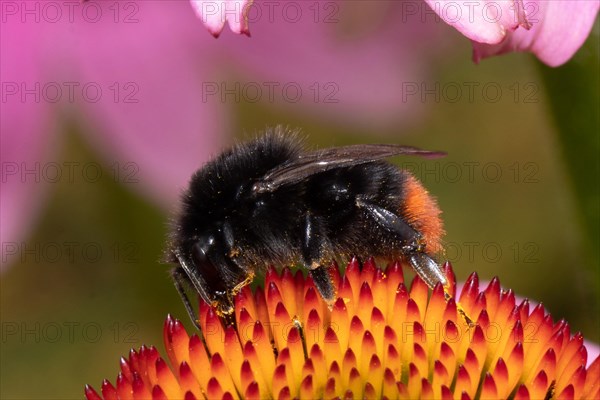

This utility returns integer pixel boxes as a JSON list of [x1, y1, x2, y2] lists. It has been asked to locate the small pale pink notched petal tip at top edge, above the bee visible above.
[[190, 0, 252, 37]]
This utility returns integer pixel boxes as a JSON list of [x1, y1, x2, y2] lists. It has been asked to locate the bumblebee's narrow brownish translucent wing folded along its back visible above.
[[252, 144, 446, 193]]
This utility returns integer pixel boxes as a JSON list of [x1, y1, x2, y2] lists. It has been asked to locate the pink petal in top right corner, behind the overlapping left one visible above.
[[473, 0, 600, 67]]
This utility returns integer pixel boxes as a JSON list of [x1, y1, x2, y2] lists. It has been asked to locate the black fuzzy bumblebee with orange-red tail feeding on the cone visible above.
[[168, 127, 447, 325]]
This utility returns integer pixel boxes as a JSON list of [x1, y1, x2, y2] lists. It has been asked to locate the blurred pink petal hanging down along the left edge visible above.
[[0, 17, 57, 268]]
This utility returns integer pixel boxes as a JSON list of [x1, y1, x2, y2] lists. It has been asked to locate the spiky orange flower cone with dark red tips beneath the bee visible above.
[[85, 260, 600, 400]]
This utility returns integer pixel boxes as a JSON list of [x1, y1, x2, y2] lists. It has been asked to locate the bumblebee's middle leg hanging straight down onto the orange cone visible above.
[[302, 213, 335, 304]]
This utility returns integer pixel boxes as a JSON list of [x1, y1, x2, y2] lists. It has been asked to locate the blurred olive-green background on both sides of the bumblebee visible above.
[[0, 17, 600, 399]]
